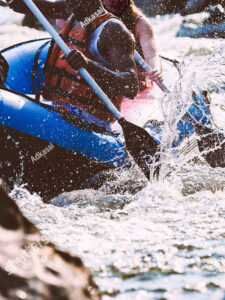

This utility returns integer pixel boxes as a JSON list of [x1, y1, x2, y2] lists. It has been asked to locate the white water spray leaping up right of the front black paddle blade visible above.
[[158, 42, 225, 178]]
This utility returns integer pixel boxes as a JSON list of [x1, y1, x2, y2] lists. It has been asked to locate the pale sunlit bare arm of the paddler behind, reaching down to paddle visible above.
[[135, 16, 162, 81]]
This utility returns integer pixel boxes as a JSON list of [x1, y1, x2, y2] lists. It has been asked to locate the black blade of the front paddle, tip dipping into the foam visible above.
[[118, 118, 159, 180]]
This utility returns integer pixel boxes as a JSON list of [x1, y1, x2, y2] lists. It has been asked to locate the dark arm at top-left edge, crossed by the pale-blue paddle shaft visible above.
[[7, 0, 70, 20]]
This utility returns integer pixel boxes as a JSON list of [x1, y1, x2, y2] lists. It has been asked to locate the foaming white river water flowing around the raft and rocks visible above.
[[0, 8, 225, 300]]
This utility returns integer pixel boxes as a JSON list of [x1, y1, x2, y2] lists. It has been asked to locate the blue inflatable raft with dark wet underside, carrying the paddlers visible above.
[[0, 39, 215, 199]]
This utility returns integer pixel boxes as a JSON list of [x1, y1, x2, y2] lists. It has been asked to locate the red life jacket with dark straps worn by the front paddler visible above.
[[42, 13, 123, 122]]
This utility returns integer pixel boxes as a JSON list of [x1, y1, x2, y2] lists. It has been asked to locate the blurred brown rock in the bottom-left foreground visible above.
[[0, 187, 100, 300]]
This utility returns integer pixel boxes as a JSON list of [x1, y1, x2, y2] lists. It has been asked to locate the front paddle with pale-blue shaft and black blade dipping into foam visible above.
[[20, 0, 158, 179]]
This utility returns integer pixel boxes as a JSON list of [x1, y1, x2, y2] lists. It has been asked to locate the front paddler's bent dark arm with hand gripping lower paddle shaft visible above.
[[67, 23, 138, 99]]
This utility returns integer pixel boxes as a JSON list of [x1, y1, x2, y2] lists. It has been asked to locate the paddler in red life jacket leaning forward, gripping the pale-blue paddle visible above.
[[6, 0, 139, 127]]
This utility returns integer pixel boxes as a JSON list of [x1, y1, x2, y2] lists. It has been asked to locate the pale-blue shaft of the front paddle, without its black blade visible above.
[[23, 0, 122, 120]]
